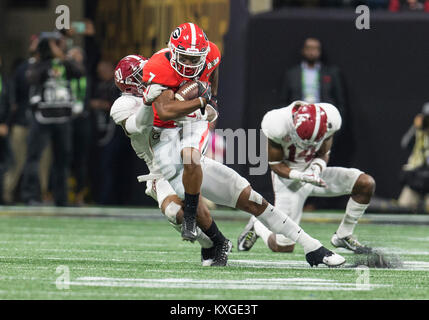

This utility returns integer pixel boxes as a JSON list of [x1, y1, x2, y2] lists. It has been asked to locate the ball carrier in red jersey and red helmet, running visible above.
[[143, 23, 222, 248]]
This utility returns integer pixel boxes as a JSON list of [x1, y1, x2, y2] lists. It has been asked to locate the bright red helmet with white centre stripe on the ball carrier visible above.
[[168, 22, 210, 78]]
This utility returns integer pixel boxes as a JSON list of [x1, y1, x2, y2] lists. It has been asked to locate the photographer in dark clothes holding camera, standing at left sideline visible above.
[[21, 32, 84, 206]]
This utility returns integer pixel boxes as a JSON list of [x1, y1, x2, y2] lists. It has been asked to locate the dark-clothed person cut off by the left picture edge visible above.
[[0, 56, 10, 205]]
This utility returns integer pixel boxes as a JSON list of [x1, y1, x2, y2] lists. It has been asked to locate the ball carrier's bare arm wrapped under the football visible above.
[[153, 90, 207, 121]]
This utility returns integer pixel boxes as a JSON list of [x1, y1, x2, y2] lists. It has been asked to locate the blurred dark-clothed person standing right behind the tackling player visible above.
[[89, 60, 131, 205]]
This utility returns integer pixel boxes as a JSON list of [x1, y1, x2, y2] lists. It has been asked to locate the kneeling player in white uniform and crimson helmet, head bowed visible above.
[[238, 101, 375, 253]]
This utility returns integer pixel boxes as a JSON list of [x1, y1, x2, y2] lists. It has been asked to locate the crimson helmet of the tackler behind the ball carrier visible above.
[[115, 55, 147, 96]]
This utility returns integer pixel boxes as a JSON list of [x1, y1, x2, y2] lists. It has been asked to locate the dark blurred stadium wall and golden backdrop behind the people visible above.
[[0, 0, 429, 211]]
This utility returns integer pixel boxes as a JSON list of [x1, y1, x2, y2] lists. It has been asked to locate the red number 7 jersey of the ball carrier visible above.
[[143, 41, 221, 128]]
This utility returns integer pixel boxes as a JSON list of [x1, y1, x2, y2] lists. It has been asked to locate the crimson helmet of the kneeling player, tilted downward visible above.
[[291, 104, 328, 150]]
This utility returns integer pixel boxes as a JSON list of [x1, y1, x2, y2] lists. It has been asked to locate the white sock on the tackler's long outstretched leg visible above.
[[257, 204, 322, 254]]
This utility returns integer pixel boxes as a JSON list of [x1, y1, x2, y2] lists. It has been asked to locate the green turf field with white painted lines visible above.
[[0, 209, 429, 300]]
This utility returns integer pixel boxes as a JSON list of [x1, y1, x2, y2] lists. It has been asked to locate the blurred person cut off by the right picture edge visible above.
[[398, 102, 429, 212]]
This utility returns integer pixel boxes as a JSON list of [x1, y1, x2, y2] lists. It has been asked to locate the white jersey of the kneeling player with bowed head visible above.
[[261, 101, 341, 170]]
